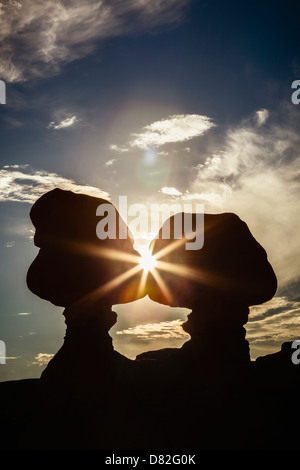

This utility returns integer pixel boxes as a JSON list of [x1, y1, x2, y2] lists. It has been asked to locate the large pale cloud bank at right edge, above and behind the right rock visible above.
[[186, 105, 300, 286]]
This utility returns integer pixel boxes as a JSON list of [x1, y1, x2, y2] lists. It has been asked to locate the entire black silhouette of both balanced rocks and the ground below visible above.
[[0, 189, 299, 450]]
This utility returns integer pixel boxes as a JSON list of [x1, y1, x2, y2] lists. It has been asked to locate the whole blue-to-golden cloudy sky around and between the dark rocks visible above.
[[0, 0, 300, 381]]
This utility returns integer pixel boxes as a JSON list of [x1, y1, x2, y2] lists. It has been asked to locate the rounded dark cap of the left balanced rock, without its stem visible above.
[[27, 189, 137, 307]]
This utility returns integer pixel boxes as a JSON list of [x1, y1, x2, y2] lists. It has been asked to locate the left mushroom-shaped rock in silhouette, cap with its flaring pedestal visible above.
[[27, 189, 143, 410]]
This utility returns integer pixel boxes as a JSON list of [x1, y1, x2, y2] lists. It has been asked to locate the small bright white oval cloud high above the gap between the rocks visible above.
[[129, 114, 215, 149]]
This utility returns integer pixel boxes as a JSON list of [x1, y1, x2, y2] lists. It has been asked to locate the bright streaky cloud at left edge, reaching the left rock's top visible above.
[[0, 165, 109, 203]]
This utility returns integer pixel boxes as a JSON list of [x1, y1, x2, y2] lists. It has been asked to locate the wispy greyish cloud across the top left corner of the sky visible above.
[[0, 0, 189, 82]]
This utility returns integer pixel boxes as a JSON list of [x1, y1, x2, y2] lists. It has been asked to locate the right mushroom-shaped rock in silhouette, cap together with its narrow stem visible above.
[[149, 213, 277, 378]]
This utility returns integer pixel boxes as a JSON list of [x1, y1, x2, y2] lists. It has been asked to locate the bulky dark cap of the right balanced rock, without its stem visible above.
[[149, 213, 277, 308]]
